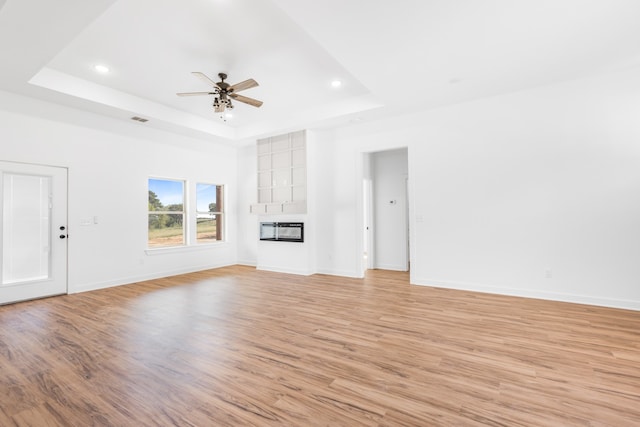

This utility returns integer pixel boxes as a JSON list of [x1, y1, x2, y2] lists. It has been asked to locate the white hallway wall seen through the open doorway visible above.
[[372, 149, 408, 271]]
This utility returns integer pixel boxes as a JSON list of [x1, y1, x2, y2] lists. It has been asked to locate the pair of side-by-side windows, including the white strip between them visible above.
[[147, 178, 224, 249]]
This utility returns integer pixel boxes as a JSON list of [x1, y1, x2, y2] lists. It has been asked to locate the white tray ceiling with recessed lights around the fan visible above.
[[0, 0, 640, 141]]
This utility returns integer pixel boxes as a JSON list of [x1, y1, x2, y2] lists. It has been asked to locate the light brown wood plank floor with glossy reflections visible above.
[[0, 266, 640, 427]]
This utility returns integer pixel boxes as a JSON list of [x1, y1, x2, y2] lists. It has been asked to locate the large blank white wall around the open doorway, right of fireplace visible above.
[[310, 70, 640, 309]]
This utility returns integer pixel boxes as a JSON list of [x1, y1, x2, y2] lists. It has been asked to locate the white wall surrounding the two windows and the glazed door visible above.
[[0, 92, 238, 292]]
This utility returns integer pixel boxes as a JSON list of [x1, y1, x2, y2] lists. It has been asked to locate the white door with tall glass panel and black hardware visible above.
[[0, 162, 68, 304]]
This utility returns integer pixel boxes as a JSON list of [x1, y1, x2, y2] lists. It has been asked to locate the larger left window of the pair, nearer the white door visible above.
[[147, 178, 185, 248]]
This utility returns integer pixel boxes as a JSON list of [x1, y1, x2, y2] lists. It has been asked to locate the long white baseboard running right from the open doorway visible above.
[[411, 278, 640, 311]]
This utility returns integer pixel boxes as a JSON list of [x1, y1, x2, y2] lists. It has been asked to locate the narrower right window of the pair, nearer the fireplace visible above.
[[196, 183, 223, 243]]
